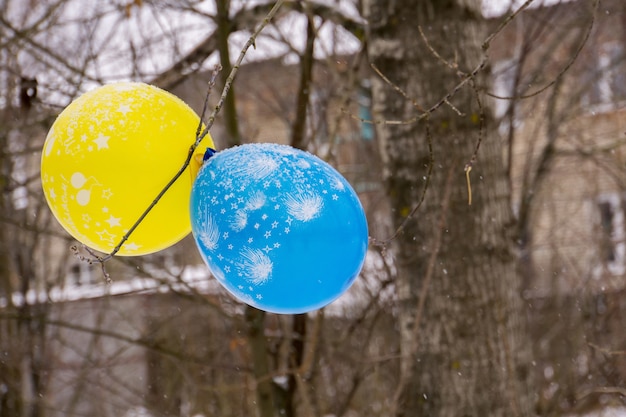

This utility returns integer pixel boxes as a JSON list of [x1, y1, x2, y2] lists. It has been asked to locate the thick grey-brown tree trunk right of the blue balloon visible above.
[[365, 0, 532, 417]]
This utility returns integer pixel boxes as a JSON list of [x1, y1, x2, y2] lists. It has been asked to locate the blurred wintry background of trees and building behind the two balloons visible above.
[[0, 0, 626, 417]]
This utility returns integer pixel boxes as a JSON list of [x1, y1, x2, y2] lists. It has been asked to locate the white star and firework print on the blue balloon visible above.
[[199, 148, 345, 285]]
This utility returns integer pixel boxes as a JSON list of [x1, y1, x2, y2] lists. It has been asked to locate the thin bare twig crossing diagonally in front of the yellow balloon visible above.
[[96, 0, 284, 266]]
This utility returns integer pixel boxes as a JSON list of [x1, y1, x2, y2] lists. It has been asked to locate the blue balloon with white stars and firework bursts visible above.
[[190, 143, 368, 314]]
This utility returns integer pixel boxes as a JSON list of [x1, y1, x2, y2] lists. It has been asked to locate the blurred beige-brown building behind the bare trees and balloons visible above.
[[0, 0, 626, 417]]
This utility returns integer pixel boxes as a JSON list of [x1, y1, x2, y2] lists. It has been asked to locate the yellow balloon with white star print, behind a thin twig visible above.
[[41, 82, 214, 256]]
